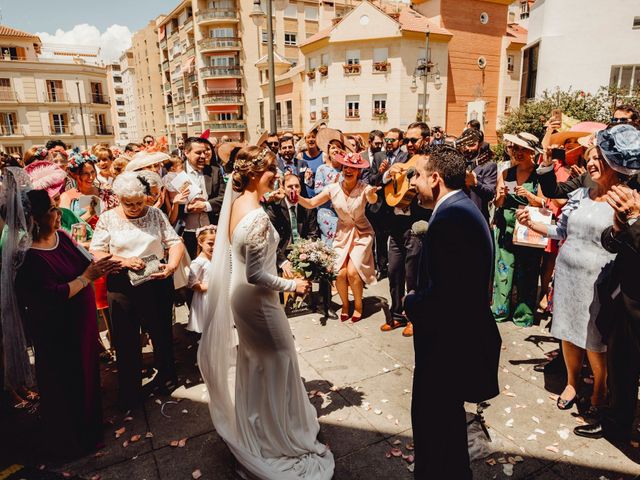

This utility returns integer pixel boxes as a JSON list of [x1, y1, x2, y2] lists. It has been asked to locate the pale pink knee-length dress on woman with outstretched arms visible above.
[[326, 182, 376, 284]]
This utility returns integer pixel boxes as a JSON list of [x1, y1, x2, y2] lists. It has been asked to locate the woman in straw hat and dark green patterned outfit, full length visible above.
[[492, 133, 544, 327]]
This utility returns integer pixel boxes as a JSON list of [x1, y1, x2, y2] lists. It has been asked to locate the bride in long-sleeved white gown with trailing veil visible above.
[[198, 147, 334, 480]]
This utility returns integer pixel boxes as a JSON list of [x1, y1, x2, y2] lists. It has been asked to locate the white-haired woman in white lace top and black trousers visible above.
[[91, 172, 184, 410]]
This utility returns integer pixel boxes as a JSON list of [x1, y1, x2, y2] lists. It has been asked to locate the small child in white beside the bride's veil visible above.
[[187, 225, 216, 333]]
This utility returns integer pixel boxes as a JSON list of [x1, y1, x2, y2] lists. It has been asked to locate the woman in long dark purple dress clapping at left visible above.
[[16, 190, 117, 458]]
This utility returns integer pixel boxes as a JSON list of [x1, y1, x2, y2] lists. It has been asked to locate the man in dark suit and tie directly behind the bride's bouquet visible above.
[[267, 173, 320, 277]]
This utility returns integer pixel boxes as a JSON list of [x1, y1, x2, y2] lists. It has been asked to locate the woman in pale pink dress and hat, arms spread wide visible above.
[[299, 144, 378, 323]]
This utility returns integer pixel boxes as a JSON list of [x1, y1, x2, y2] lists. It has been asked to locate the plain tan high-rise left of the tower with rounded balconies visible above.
[[125, 16, 167, 142]]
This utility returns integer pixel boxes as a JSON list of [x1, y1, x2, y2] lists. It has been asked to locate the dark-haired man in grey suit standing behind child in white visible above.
[[178, 137, 225, 258]]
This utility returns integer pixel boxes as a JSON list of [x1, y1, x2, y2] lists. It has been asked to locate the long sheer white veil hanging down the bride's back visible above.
[[198, 186, 240, 439]]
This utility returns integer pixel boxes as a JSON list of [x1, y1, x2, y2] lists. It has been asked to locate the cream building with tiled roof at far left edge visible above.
[[0, 25, 114, 155]]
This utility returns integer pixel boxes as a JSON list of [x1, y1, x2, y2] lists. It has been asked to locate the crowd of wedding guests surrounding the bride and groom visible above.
[[0, 105, 640, 464]]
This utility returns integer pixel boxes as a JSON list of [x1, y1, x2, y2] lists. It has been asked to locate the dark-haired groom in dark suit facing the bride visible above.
[[404, 145, 501, 480]]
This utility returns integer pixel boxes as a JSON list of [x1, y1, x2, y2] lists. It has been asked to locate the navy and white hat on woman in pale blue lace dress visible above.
[[597, 124, 640, 175]]
